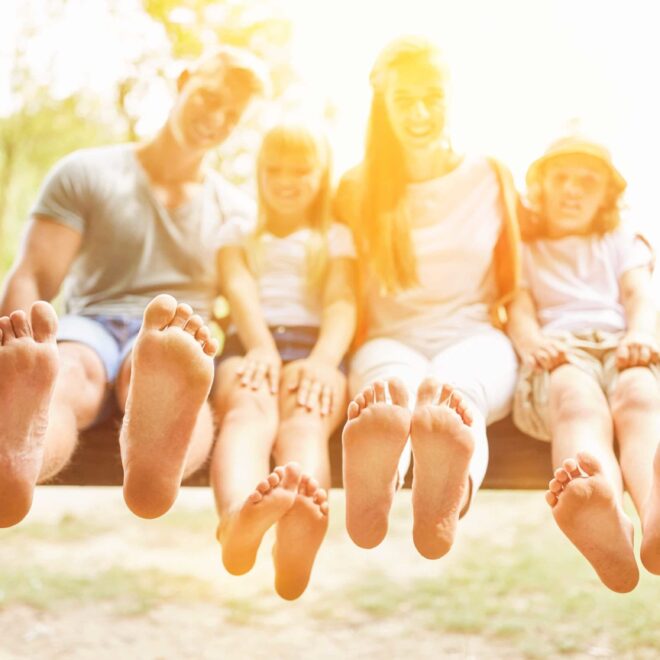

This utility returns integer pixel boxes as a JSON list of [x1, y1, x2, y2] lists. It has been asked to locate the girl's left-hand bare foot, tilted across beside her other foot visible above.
[[218, 463, 300, 575]]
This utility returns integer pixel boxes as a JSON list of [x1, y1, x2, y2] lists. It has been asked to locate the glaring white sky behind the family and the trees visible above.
[[0, 0, 660, 301]]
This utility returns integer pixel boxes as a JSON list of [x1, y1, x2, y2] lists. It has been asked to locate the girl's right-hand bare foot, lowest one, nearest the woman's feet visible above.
[[273, 475, 328, 600]]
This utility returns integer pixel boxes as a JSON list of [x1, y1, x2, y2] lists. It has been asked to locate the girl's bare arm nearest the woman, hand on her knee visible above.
[[286, 258, 357, 415]]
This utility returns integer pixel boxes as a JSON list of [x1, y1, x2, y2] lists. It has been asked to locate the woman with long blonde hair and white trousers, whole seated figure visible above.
[[335, 37, 519, 558]]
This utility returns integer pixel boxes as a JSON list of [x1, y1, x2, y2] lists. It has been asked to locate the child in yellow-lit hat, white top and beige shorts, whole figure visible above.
[[511, 136, 660, 592]]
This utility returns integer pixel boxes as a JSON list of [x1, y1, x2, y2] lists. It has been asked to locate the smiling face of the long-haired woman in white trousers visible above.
[[383, 60, 446, 151]]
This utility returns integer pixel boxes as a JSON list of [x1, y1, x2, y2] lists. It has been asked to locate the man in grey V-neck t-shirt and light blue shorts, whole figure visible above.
[[0, 46, 263, 527]]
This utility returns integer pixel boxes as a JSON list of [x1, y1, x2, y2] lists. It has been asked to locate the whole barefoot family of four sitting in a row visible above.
[[0, 37, 660, 599]]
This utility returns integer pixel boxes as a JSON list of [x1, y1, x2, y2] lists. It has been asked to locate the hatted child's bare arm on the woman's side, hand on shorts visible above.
[[506, 289, 568, 371]]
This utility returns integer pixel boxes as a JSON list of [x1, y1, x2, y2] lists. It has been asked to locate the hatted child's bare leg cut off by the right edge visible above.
[[610, 368, 660, 575]]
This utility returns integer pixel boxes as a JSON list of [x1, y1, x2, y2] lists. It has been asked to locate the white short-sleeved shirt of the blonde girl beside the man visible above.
[[218, 218, 356, 327]]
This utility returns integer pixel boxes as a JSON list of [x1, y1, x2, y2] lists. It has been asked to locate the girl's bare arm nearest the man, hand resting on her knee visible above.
[[217, 245, 282, 394]]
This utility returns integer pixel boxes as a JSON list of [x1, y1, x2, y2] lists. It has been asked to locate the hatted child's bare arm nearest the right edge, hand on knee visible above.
[[617, 266, 659, 370]]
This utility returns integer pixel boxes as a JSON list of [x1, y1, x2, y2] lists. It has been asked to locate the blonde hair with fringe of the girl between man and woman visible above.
[[248, 122, 332, 291]]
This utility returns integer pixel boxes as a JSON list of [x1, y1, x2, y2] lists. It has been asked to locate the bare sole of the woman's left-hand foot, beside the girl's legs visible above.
[[342, 379, 410, 548]]
